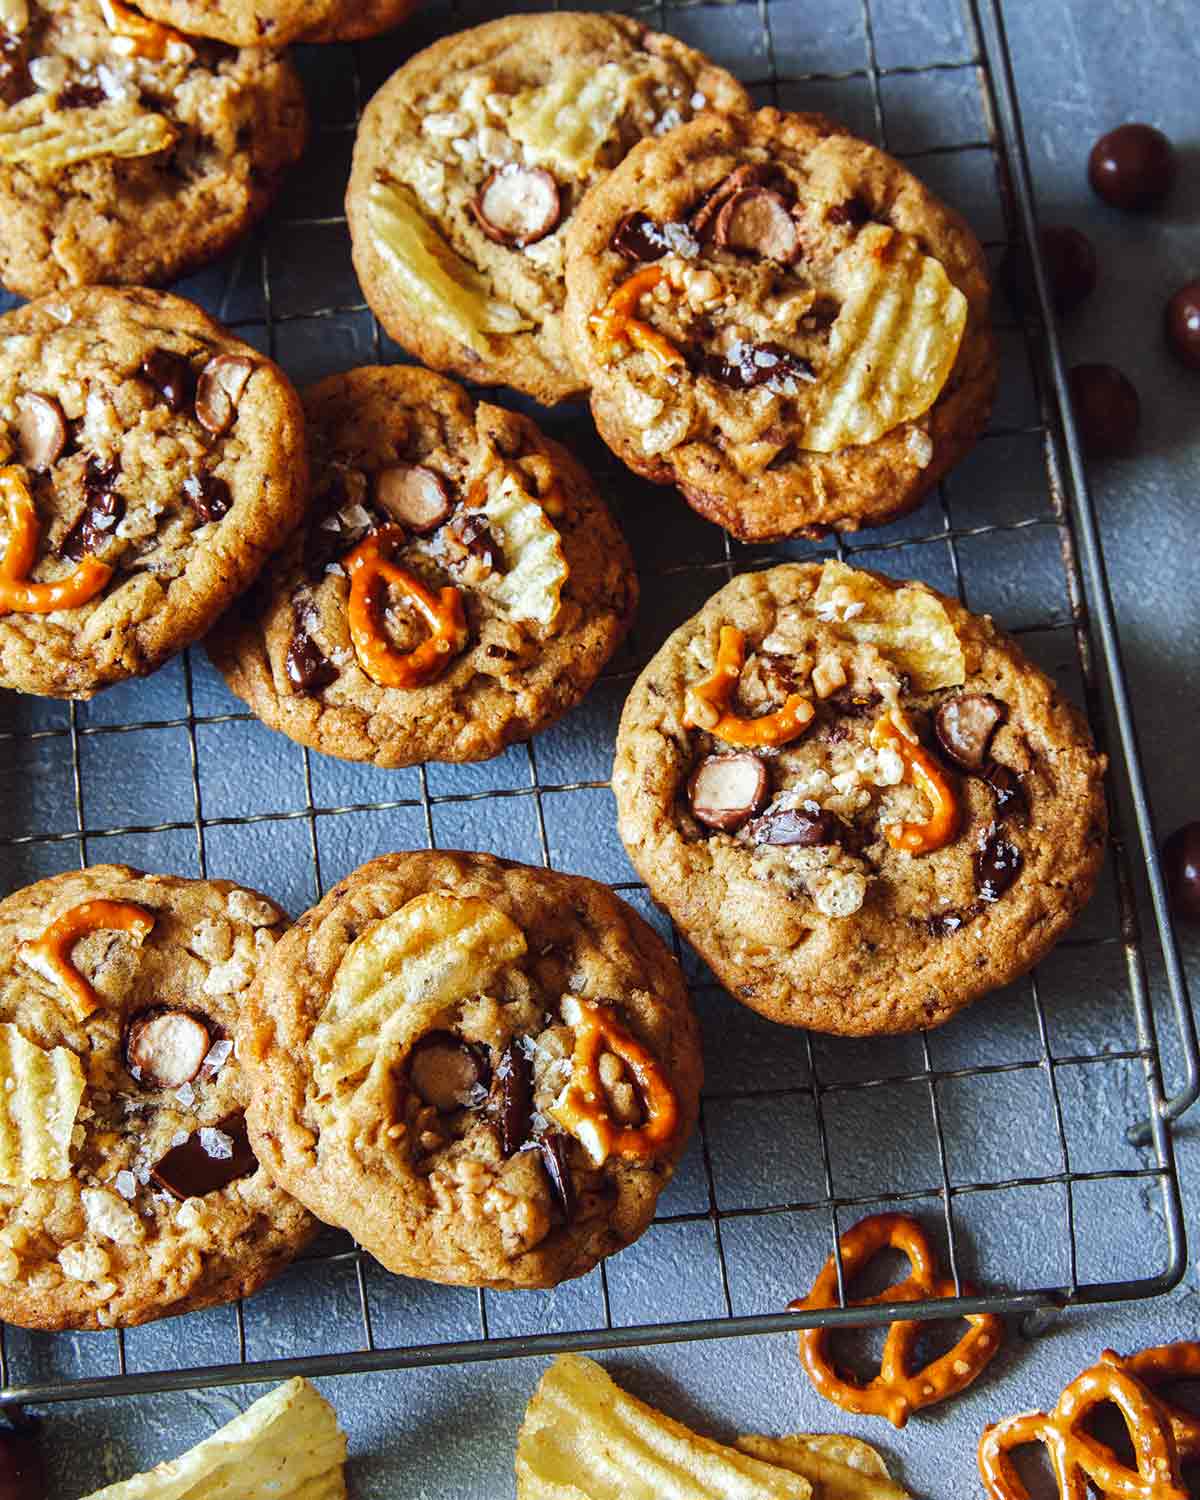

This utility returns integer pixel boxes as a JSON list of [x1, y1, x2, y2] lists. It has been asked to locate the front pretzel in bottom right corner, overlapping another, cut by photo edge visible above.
[[978, 1362, 1188, 1500]]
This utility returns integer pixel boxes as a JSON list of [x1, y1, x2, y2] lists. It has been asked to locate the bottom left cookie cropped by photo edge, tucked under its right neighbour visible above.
[[0, 864, 314, 1329]]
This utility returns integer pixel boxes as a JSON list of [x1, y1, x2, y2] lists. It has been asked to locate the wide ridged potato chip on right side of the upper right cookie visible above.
[[798, 224, 968, 453]]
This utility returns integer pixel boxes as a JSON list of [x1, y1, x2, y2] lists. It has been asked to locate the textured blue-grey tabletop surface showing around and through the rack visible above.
[[0, 0, 1200, 1500]]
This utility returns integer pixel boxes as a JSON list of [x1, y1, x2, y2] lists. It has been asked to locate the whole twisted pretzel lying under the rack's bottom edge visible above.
[[788, 1214, 1004, 1427]]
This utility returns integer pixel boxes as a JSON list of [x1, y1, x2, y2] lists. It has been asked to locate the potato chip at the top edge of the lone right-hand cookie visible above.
[[810, 561, 966, 693]]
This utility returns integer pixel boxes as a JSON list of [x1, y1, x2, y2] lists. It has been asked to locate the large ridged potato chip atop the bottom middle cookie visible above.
[[312, 891, 525, 1095]]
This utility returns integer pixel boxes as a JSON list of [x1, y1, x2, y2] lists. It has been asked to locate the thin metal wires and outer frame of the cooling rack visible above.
[[0, 0, 1200, 1407]]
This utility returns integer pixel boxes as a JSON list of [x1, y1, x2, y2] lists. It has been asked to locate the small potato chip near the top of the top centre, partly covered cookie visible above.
[[509, 62, 633, 177]]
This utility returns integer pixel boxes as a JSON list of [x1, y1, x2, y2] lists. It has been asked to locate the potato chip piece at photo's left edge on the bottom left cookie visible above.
[[0, 1022, 84, 1188]]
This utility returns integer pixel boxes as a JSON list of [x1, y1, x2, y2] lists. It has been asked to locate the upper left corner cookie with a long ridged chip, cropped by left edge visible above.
[[0, 0, 306, 297]]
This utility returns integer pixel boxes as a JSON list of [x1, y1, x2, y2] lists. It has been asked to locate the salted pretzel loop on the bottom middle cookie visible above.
[[546, 995, 680, 1166]]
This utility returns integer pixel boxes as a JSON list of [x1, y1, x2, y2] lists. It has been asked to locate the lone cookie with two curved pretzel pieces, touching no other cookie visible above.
[[614, 561, 1106, 1035]]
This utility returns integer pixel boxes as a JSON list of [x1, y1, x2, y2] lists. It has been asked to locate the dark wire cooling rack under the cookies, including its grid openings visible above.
[[0, 0, 1200, 1404]]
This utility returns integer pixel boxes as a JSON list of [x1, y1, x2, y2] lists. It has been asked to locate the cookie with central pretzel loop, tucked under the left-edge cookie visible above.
[[209, 365, 638, 767]]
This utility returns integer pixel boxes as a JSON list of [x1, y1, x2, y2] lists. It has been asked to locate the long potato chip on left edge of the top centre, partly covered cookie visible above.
[[366, 182, 530, 354]]
